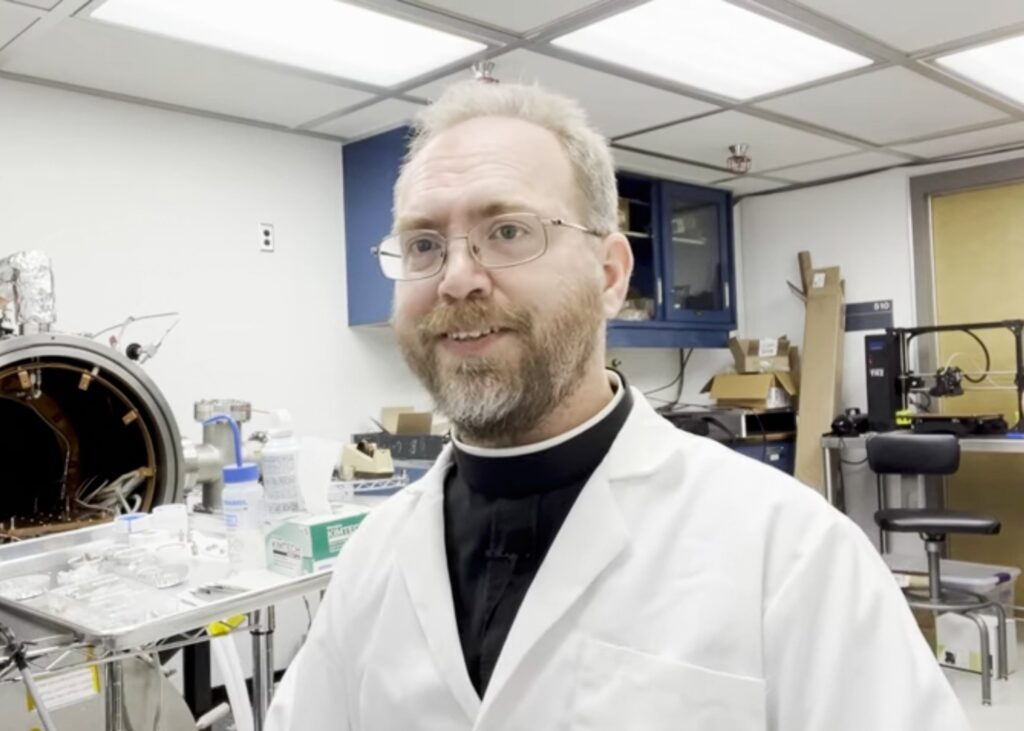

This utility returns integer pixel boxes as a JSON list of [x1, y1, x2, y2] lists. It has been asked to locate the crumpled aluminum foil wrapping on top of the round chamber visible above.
[[0, 251, 56, 332]]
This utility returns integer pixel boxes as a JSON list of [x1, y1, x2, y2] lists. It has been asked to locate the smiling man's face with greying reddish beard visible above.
[[393, 118, 617, 443]]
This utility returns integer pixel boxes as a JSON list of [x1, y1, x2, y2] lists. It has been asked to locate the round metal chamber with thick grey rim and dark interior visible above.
[[0, 333, 185, 540]]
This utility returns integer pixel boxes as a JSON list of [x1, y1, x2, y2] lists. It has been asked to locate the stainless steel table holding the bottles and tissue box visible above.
[[0, 524, 331, 731]]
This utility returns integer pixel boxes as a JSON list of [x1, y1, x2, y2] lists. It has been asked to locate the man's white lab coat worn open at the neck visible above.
[[267, 391, 968, 731]]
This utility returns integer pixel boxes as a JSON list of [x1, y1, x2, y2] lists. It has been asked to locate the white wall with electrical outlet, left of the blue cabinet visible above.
[[0, 80, 427, 438]]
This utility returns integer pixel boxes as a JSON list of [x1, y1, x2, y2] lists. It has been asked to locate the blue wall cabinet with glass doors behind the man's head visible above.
[[342, 127, 736, 348]]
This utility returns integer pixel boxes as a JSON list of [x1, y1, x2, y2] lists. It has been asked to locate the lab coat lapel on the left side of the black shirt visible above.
[[398, 453, 480, 722]]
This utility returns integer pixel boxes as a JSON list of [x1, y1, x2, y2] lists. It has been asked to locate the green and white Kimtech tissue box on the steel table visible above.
[[266, 505, 368, 576]]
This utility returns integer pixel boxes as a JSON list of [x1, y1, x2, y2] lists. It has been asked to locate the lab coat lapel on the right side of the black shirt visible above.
[[480, 468, 629, 720]]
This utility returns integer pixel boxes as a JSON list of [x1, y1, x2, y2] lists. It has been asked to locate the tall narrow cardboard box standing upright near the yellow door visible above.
[[795, 257, 846, 492]]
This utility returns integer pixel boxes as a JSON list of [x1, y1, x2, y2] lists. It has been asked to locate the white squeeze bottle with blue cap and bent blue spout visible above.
[[206, 415, 266, 571]]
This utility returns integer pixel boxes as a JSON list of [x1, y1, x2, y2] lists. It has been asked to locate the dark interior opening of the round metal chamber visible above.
[[0, 357, 160, 540]]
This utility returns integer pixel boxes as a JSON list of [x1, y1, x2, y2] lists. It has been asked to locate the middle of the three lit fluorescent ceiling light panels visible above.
[[552, 0, 871, 99]]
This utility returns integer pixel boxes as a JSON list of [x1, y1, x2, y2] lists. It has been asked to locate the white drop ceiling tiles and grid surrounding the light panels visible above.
[[0, 0, 1024, 195]]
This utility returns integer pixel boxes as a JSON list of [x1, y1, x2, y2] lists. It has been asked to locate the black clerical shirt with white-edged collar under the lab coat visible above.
[[444, 375, 633, 697]]
